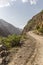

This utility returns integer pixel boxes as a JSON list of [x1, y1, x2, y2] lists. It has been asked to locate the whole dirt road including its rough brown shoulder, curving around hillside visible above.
[[8, 31, 43, 65]]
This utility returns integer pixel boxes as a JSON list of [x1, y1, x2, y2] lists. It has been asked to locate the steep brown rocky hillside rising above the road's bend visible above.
[[23, 10, 43, 33]]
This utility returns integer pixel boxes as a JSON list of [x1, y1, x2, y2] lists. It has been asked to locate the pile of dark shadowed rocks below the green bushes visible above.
[[0, 45, 10, 65]]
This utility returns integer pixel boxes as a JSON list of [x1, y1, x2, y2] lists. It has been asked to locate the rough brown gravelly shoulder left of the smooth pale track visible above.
[[8, 32, 37, 65]]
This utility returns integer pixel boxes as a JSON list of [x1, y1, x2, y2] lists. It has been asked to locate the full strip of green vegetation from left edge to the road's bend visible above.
[[0, 34, 26, 49]]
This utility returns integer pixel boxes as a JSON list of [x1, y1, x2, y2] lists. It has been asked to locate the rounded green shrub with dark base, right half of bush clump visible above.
[[9, 35, 21, 47]]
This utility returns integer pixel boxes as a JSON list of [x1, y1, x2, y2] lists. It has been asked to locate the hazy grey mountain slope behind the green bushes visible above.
[[0, 19, 21, 36]]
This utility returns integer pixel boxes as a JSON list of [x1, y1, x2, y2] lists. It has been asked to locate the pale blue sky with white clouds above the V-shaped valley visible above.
[[0, 0, 43, 29]]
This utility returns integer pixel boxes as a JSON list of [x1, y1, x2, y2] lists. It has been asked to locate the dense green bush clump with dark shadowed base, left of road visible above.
[[1, 35, 21, 48]]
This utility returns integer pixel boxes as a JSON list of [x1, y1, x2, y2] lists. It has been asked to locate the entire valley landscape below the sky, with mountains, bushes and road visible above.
[[0, 10, 43, 65]]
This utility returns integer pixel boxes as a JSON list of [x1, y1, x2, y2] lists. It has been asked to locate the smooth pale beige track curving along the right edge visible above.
[[28, 31, 43, 65]]
